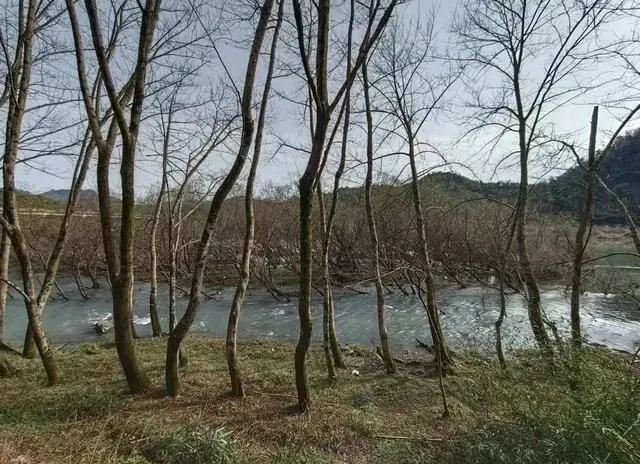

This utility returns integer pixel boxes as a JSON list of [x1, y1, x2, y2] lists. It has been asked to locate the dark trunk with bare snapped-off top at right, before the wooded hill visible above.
[[571, 106, 598, 349]]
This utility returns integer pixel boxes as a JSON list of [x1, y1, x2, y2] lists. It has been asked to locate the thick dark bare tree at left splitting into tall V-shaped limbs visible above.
[[66, 0, 160, 393]]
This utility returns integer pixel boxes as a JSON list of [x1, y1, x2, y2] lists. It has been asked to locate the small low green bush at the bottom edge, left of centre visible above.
[[154, 424, 235, 464]]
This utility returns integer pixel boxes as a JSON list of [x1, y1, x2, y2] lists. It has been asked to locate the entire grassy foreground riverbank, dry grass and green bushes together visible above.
[[0, 337, 640, 464]]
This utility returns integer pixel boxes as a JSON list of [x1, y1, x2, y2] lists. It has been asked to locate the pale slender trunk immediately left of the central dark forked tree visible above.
[[226, 0, 285, 397]]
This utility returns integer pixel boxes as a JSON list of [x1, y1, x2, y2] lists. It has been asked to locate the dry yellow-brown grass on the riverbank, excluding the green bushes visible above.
[[0, 337, 636, 464]]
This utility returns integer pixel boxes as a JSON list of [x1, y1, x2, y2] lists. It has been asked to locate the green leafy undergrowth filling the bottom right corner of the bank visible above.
[[442, 350, 640, 464]]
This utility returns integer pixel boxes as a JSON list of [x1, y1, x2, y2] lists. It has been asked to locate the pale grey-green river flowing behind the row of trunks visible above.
[[5, 279, 640, 352]]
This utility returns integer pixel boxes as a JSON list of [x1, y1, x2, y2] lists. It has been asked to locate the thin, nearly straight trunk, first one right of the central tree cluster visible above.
[[362, 60, 396, 374]]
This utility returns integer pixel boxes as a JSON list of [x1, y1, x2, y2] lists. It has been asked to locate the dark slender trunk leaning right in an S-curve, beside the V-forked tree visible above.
[[165, 0, 274, 396]]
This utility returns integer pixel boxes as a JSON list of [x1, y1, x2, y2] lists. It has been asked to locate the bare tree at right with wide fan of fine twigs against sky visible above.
[[456, 0, 620, 351]]
